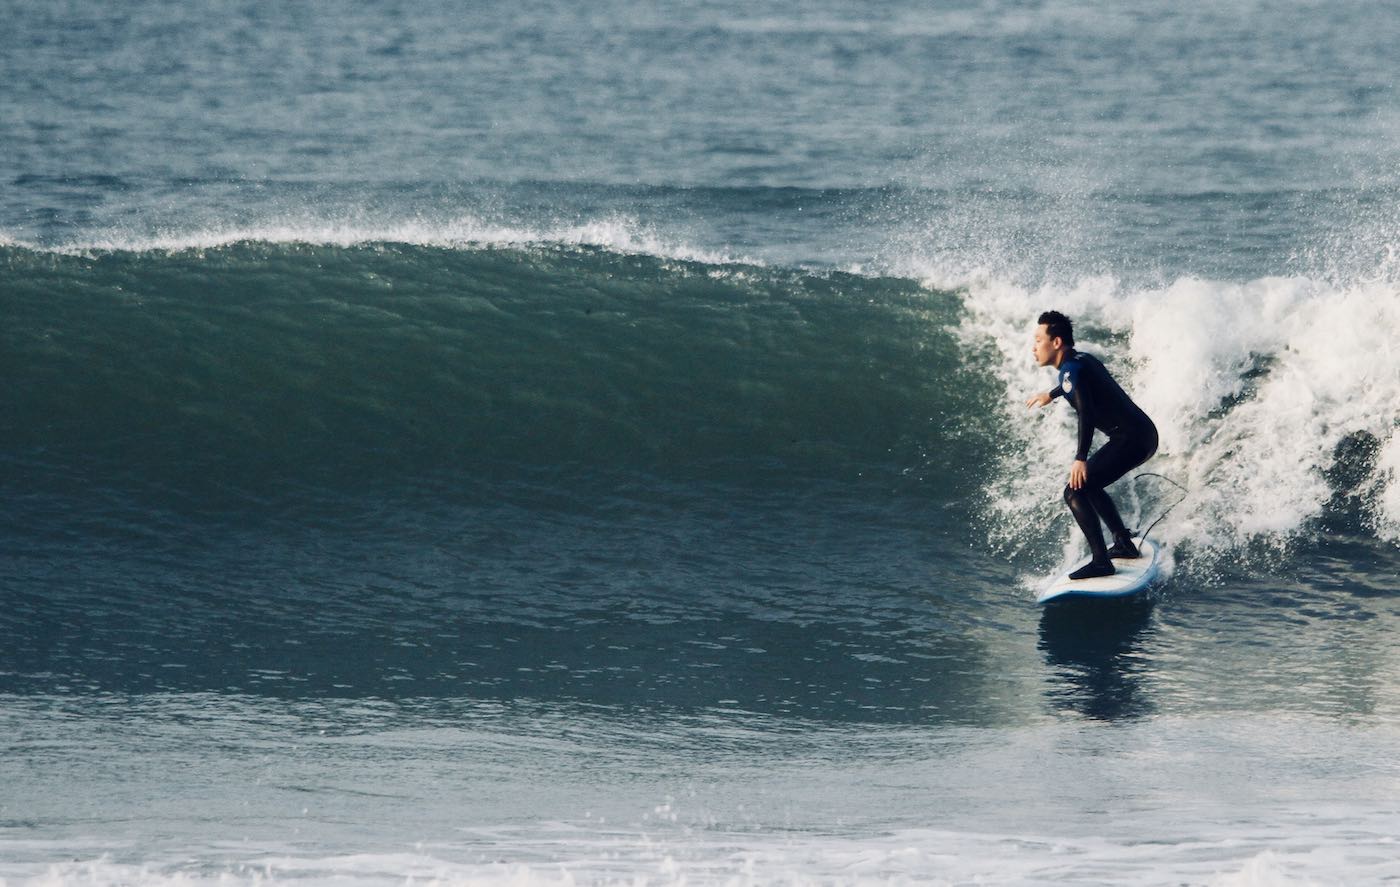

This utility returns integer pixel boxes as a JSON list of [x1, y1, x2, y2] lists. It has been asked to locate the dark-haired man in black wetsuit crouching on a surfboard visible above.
[[1026, 311, 1156, 579]]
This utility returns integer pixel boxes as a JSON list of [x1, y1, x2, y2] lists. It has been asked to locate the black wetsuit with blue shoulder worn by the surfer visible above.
[[1050, 350, 1156, 564]]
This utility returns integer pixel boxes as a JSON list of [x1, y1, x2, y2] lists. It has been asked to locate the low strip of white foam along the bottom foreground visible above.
[[3, 828, 1393, 887]]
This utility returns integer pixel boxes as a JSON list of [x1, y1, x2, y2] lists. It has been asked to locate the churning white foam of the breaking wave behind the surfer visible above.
[[925, 264, 1400, 559]]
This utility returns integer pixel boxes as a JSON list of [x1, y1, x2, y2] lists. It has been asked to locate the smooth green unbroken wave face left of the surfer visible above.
[[4, 243, 990, 491]]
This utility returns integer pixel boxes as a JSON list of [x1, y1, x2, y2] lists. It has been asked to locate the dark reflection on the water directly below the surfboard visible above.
[[1037, 599, 1155, 721]]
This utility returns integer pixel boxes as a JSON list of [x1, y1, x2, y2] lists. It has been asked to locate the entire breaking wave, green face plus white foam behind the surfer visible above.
[[3, 242, 1400, 550]]
